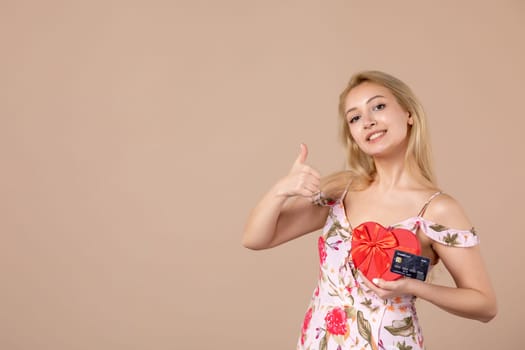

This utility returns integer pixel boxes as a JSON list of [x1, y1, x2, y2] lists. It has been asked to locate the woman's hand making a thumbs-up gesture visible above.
[[279, 143, 321, 198]]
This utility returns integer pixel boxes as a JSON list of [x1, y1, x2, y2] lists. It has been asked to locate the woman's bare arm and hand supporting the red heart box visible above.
[[358, 195, 497, 322]]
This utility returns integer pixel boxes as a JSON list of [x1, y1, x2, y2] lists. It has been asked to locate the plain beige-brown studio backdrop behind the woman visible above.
[[0, 0, 525, 350]]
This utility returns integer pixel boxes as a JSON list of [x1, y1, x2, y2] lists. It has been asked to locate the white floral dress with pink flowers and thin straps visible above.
[[297, 192, 479, 350]]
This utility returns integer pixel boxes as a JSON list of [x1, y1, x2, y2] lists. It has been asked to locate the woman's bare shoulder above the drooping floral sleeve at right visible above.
[[424, 193, 472, 230]]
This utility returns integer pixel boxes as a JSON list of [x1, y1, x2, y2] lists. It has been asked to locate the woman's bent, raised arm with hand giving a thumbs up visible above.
[[242, 144, 328, 250]]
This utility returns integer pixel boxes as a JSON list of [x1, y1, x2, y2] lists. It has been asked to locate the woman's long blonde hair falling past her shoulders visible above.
[[321, 71, 436, 198]]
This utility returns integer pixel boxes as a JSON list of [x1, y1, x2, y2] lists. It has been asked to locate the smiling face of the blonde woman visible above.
[[345, 82, 413, 157]]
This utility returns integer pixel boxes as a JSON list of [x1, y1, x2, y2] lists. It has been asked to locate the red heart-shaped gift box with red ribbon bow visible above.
[[350, 222, 421, 281]]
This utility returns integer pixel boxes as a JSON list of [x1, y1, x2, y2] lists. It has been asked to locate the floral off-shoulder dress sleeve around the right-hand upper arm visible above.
[[419, 219, 479, 247]]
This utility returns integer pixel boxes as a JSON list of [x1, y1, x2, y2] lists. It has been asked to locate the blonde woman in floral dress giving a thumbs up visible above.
[[243, 71, 497, 350]]
